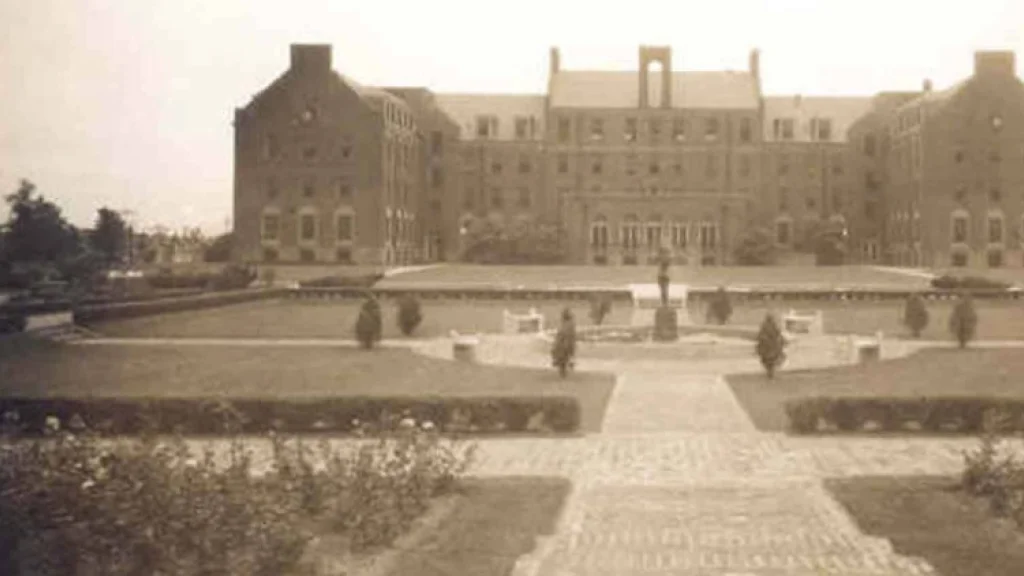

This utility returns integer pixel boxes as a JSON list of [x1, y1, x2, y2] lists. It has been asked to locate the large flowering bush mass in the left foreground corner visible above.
[[0, 413, 475, 576]]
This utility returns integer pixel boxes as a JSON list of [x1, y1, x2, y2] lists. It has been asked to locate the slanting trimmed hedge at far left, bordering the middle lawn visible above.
[[75, 288, 286, 324]]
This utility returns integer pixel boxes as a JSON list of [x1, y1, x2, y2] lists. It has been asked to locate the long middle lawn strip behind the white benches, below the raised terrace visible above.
[[94, 299, 1024, 340]]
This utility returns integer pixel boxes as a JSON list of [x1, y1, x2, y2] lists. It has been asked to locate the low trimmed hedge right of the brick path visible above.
[[785, 397, 1024, 434]]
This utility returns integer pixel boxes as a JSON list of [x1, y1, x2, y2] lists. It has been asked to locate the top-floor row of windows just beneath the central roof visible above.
[[556, 117, 754, 143]]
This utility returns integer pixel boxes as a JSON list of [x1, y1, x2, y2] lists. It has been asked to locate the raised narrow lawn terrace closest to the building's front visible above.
[[378, 264, 928, 288]]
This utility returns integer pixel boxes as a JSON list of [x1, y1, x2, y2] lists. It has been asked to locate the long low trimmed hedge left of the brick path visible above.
[[0, 397, 581, 436]]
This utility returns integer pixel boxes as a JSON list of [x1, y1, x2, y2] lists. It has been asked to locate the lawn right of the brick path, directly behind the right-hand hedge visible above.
[[727, 348, 1024, 430]]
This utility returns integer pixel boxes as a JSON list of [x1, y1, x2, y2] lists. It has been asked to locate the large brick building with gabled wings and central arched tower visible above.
[[234, 45, 1024, 265]]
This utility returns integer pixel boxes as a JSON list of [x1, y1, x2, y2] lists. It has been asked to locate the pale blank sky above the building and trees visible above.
[[0, 0, 1024, 233]]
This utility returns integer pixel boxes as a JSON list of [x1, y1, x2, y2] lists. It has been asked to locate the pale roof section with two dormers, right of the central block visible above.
[[764, 94, 872, 142]]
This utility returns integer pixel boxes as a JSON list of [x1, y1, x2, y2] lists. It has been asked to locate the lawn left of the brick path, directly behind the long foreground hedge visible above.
[[0, 345, 614, 431]]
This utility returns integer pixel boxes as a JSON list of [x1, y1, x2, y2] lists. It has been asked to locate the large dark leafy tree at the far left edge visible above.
[[2, 180, 80, 263]]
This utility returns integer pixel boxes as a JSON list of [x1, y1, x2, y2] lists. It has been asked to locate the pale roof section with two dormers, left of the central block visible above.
[[435, 94, 545, 140]]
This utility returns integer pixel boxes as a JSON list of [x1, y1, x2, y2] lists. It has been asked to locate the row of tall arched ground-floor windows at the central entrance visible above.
[[590, 215, 718, 251]]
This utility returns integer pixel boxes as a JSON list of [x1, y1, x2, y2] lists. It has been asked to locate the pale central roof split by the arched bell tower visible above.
[[550, 70, 759, 110]]
